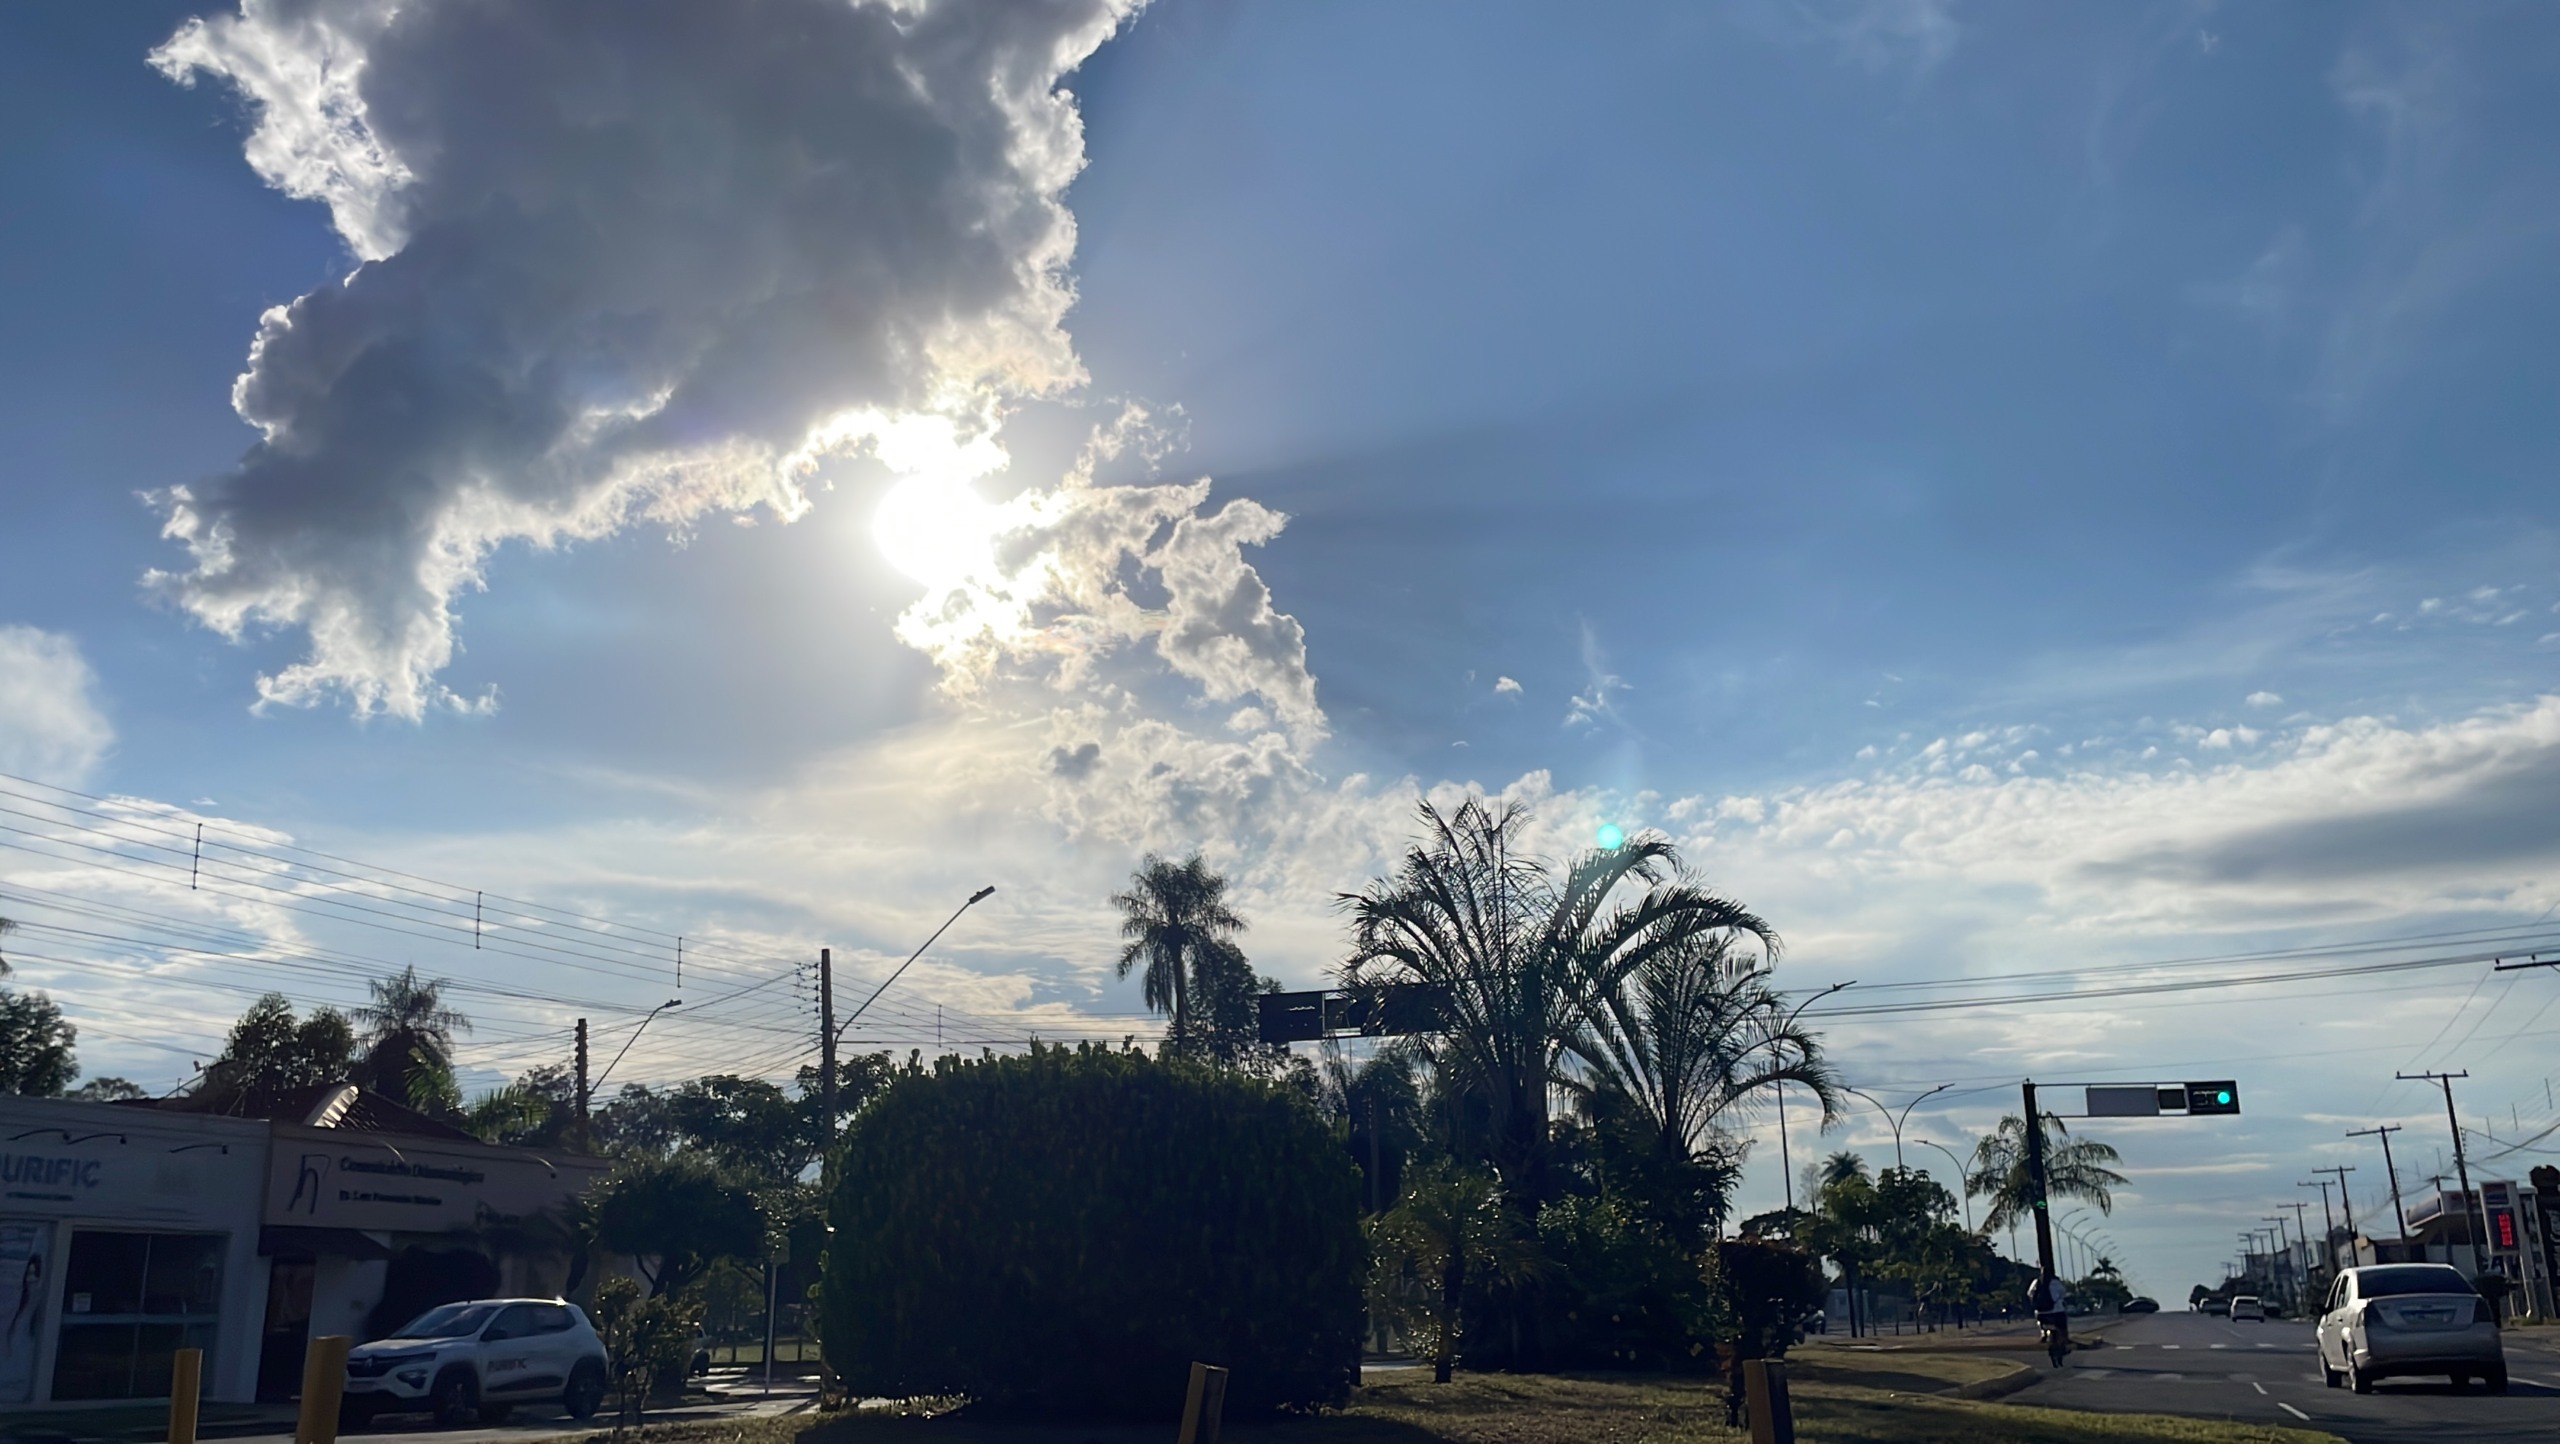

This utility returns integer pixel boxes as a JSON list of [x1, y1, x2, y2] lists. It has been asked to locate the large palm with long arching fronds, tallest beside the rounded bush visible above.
[[1341, 796, 1779, 1219]]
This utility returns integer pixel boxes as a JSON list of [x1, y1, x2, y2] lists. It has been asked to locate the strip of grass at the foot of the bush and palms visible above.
[[599, 1349, 2340, 1444]]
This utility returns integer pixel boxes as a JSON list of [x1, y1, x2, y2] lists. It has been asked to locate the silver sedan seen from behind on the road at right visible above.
[[2319, 1265, 2506, 1393]]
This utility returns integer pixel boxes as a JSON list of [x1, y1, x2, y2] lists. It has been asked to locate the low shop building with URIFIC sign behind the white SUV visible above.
[[0, 1086, 607, 1408]]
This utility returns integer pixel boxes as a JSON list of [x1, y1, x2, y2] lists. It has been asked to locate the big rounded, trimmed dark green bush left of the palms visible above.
[[819, 1045, 1367, 1416]]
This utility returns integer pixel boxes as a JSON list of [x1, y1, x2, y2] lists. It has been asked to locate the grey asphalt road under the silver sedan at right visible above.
[[2007, 1313, 2560, 1444]]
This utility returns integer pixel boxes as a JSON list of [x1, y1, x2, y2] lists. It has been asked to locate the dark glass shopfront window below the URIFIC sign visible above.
[[54, 1229, 223, 1398]]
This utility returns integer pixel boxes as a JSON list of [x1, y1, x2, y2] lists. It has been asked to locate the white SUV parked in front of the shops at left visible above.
[[340, 1298, 604, 1429]]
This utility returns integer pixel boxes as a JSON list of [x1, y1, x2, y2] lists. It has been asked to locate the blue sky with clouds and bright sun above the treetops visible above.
[[0, 0, 2560, 1298]]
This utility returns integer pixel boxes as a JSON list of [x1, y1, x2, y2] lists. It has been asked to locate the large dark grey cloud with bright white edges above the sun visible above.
[[148, 0, 1131, 717]]
